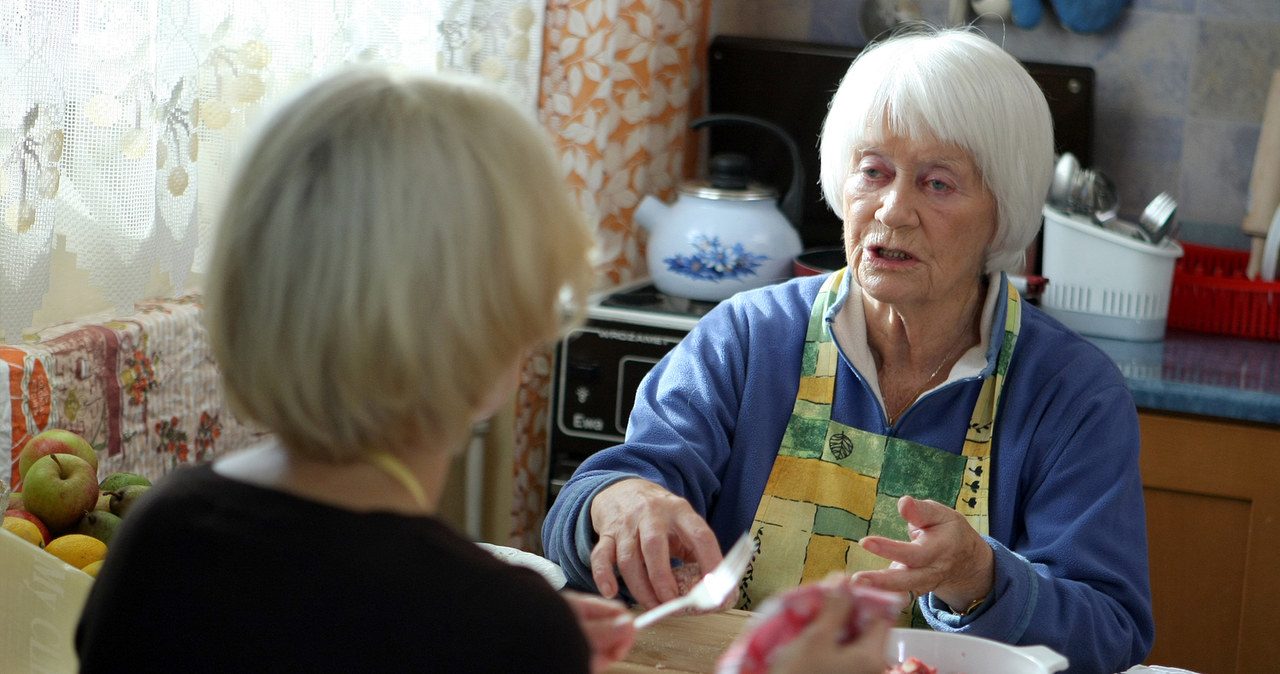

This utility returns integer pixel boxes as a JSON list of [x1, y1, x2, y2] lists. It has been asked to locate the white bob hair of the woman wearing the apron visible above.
[[819, 27, 1053, 274]]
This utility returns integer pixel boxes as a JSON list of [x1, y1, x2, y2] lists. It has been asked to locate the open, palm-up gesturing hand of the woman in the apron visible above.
[[854, 496, 996, 611]]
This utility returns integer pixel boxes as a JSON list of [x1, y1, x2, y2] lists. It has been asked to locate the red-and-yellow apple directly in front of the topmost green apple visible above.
[[22, 454, 97, 535]]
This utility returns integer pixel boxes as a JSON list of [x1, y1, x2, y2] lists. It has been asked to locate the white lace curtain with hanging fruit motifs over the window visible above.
[[0, 0, 545, 343]]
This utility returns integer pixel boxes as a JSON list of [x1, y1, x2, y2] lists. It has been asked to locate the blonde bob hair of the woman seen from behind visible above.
[[206, 65, 594, 462]]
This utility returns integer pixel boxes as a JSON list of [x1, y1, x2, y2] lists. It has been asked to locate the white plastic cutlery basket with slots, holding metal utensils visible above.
[[1041, 206, 1183, 341]]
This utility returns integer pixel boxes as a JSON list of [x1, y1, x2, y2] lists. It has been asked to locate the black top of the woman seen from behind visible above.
[[76, 464, 589, 674]]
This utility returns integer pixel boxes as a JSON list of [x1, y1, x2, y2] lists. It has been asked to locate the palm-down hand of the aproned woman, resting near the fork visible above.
[[591, 478, 722, 609]]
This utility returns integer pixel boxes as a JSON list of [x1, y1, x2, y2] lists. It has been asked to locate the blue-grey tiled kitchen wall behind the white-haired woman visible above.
[[713, 0, 1280, 248]]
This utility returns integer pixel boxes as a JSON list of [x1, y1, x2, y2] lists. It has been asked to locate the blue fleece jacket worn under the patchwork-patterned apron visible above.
[[543, 276, 1155, 673]]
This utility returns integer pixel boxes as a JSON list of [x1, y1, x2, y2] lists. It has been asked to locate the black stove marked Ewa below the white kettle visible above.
[[547, 280, 717, 508]]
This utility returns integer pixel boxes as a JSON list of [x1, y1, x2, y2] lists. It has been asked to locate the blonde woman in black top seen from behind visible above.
[[76, 67, 634, 673]]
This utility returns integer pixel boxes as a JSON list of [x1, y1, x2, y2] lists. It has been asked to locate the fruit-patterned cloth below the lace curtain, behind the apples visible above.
[[0, 295, 259, 487]]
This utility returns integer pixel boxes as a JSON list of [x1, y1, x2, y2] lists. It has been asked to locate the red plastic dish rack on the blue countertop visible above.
[[1169, 242, 1280, 340]]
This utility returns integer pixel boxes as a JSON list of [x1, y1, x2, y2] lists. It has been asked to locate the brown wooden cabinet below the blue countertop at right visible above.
[[1139, 409, 1280, 674]]
